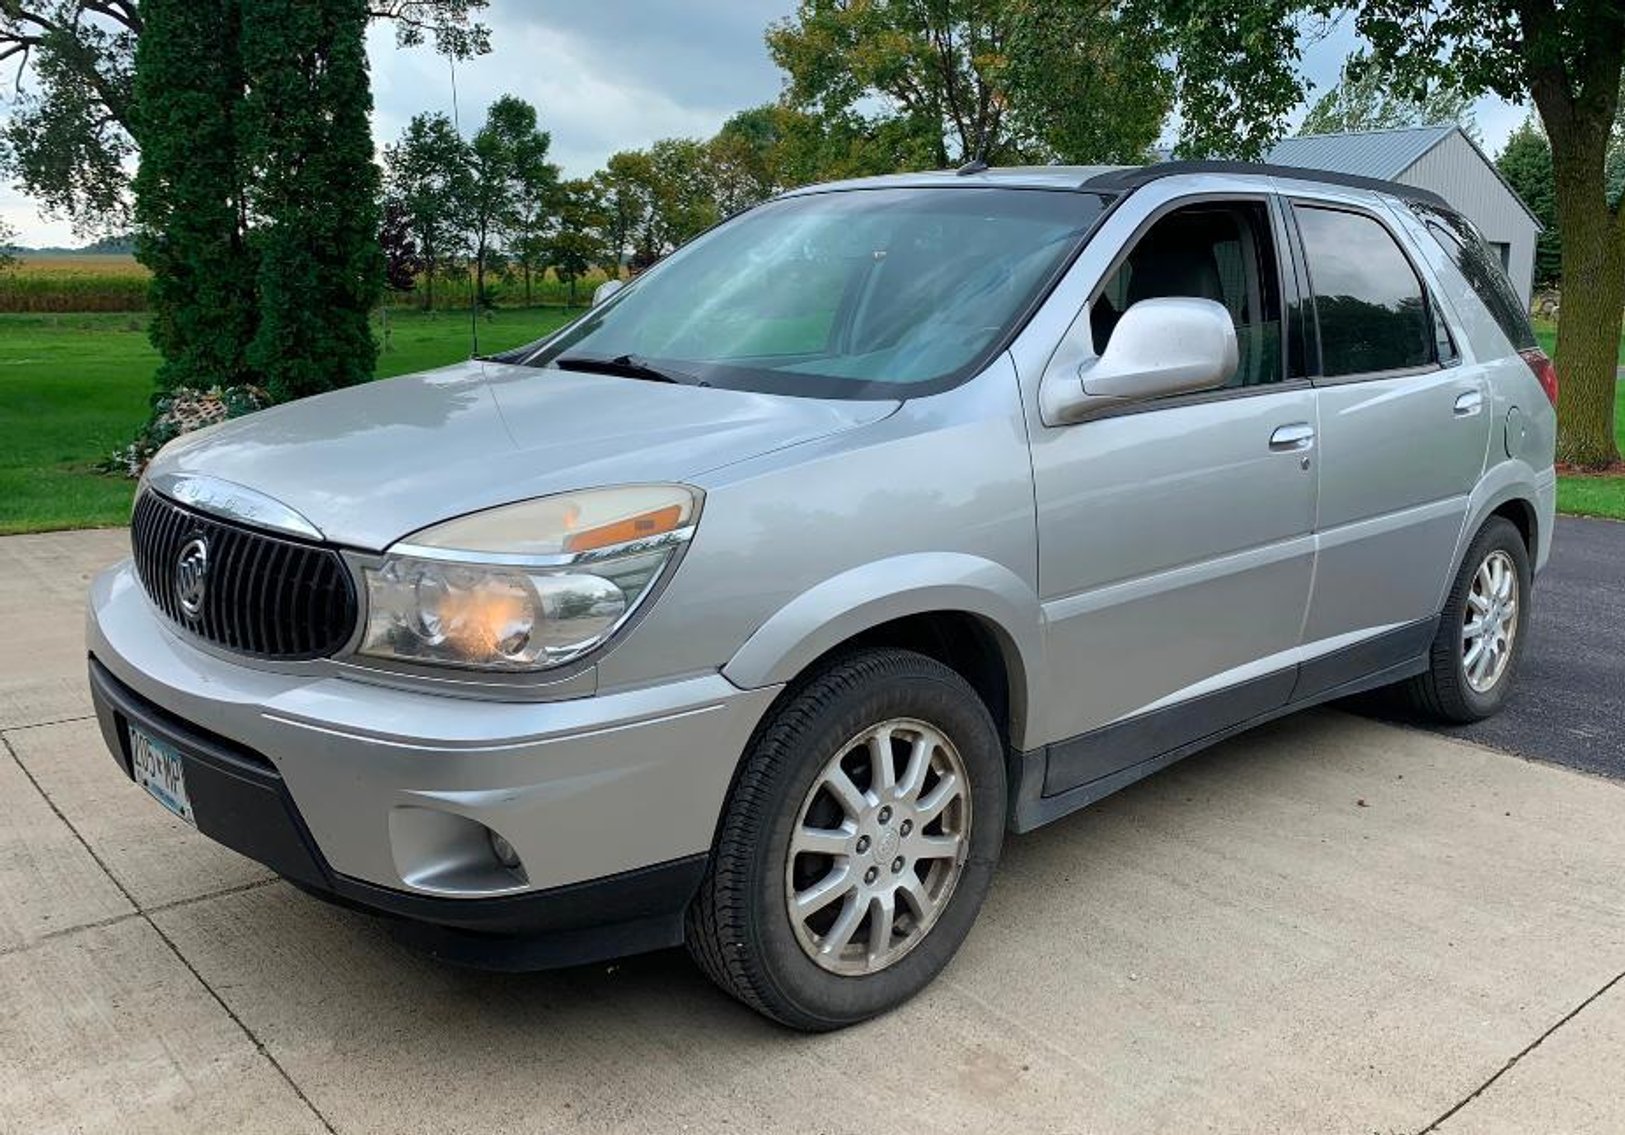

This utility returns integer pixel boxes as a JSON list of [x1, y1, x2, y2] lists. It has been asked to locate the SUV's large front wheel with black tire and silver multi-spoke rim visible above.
[[686, 650, 1006, 1033]]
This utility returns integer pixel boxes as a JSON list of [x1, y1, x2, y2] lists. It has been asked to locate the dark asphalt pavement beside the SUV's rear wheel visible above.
[[1378, 517, 1625, 781]]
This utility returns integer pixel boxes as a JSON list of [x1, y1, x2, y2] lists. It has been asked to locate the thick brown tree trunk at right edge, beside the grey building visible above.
[[1550, 120, 1625, 468]]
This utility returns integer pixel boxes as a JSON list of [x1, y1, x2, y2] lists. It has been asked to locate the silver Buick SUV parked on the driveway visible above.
[[89, 163, 1555, 1029]]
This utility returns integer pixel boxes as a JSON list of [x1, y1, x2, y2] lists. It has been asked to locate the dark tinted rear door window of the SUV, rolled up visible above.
[[1297, 205, 1435, 376]]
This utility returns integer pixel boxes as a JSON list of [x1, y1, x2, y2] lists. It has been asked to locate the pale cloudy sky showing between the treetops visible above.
[[0, 0, 1524, 246]]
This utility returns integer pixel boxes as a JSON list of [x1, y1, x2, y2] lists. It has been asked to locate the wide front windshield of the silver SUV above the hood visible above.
[[509, 187, 1105, 398]]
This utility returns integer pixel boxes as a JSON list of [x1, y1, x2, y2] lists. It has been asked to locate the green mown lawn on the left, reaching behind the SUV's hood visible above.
[[0, 307, 574, 535]]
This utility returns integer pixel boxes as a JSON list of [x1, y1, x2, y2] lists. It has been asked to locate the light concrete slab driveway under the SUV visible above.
[[0, 532, 1625, 1133]]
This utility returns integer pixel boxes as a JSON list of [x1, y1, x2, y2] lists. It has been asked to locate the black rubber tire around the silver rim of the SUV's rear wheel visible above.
[[1401, 517, 1531, 725]]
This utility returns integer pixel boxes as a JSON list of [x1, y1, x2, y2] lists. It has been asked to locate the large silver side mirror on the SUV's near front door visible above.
[[1043, 296, 1240, 423]]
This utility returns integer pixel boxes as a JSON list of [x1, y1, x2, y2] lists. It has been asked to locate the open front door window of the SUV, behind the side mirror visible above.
[[1089, 202, 1282, 387]]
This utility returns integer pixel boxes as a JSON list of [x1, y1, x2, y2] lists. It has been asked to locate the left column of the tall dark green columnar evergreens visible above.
[[135, 0, 258, 389]]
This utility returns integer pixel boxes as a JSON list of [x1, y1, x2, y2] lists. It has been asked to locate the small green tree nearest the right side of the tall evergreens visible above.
[[384, 114, 473, 311]]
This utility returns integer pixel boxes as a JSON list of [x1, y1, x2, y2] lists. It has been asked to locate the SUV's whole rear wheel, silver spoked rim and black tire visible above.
[[1406, 517, 1529, 724]]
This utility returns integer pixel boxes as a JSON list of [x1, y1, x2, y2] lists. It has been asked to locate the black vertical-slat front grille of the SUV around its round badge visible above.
[[130, 489, 358, 660]]
